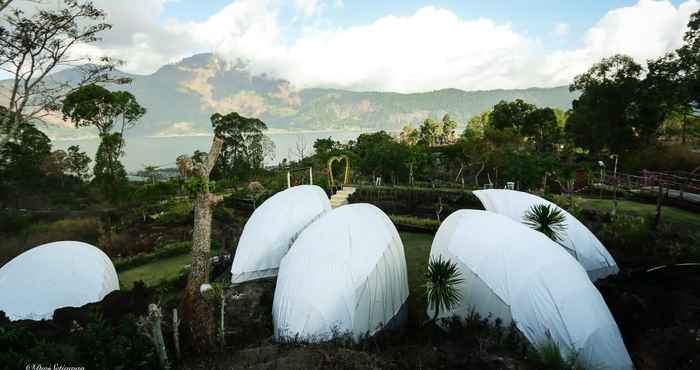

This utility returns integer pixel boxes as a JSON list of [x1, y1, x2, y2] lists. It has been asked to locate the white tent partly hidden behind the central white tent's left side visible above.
[[231, 185, 331, 283]]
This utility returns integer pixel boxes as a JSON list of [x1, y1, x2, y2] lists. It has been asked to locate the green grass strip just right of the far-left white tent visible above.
[[119, 253, 192, 289]]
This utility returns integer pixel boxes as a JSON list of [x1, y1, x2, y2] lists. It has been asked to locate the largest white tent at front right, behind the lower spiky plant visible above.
[[428, 210, 633, 370]]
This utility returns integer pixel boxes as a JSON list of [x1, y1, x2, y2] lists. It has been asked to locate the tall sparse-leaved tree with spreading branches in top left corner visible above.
[[0, 0, 128, 144]]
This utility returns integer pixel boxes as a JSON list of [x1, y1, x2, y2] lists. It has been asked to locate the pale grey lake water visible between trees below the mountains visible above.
[[52, 131, 370, 172]]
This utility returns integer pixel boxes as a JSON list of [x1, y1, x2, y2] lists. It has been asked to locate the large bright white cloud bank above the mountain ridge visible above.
[[193, 0, 700, 92]]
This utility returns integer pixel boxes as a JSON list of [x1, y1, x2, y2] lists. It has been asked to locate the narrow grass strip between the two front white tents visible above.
[[400, 232, 433, 322]]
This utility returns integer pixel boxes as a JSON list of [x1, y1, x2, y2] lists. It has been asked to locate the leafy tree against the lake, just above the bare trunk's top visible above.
[[211, 112, 274, 177]]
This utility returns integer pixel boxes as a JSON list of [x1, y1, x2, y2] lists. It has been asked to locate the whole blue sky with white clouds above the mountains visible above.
[[13, 0, 700, 92]]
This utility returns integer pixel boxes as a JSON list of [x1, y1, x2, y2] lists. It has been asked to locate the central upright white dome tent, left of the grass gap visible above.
[[272, 204, 408, 342]]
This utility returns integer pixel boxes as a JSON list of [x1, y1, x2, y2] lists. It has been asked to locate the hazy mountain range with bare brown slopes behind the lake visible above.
[[1, 54, 575, 137]]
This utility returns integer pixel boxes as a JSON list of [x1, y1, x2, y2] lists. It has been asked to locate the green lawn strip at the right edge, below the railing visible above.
[[581, 198, 700, 227]]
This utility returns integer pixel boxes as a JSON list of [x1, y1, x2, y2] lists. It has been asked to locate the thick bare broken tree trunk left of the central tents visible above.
[[183, 137, 223, 353]]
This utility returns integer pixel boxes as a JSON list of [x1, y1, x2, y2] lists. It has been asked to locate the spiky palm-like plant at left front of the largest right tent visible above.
[[425, 256, 463, 322]]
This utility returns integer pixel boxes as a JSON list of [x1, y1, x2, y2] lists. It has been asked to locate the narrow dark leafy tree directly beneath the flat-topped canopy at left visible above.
[[93, 132, 127, 194]]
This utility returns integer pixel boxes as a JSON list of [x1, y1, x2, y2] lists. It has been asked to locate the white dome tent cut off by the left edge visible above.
[[0, 241, 119, 321]]
